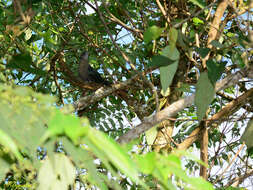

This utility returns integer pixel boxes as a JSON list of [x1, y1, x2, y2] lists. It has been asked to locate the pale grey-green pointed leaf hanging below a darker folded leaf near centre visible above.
[[160, 60, 178, 93]]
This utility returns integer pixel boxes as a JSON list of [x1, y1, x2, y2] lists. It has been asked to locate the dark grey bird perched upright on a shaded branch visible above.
[[78, 51, 111, 86]]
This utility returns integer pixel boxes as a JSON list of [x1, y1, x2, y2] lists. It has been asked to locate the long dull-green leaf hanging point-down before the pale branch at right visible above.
[[195, 72, 214, 121]]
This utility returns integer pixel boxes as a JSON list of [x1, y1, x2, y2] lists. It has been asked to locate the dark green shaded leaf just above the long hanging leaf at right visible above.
[[206, 60, 226, 85]]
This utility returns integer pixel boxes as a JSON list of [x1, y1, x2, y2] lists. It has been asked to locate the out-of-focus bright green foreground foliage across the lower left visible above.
[[0, 86, 213, 189]]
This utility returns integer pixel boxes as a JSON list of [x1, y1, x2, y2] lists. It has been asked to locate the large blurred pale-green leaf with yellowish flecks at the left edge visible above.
[[0, 85, 52, 158]]
